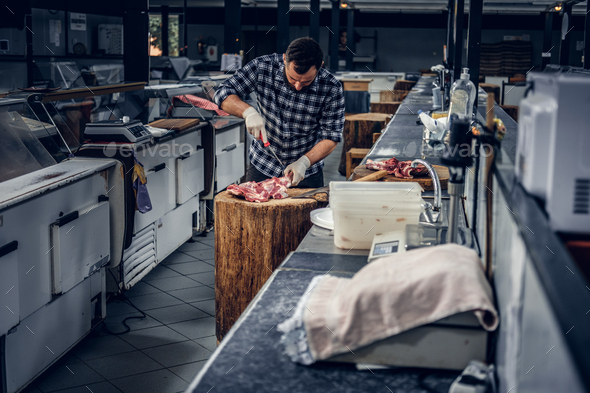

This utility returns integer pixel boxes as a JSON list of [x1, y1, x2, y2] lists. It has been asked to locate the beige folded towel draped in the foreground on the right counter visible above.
[[303, 244, 498, 361]]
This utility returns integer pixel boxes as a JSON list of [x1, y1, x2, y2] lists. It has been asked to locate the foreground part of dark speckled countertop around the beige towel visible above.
[[187, 266, 457, 393]]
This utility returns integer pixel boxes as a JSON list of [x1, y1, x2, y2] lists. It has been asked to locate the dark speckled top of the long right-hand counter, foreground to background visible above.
[[187, 77, 480, 393]]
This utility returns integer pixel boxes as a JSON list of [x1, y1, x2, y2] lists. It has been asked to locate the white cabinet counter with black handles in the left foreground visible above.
[[0, 159, 122, 393]]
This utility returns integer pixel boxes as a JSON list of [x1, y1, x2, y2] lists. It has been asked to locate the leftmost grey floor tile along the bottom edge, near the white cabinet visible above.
[[37, 362, 104, 393]]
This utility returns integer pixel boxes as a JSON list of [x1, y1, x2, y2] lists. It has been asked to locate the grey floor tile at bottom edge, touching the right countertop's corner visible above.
[[111, 370, 188, 393]]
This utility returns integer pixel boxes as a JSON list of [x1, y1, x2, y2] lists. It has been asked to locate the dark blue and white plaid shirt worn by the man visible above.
[[215, 54, 344, 177]]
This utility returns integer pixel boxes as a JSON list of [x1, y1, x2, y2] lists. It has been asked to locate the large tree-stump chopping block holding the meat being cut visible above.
[[215, 188, 328, 341]]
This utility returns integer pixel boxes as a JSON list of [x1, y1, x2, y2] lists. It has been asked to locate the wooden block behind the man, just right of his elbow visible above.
[[338, 113, 391, 176]]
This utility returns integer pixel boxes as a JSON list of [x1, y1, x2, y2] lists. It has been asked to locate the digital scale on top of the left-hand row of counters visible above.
[[84, 120, 152, 143]]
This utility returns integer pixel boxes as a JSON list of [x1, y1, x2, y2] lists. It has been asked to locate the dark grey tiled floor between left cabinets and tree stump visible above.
[[27, 143, 346, 393]]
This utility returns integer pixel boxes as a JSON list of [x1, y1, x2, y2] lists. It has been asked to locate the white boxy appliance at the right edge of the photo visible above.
[[515, 73, 590, 233]]
